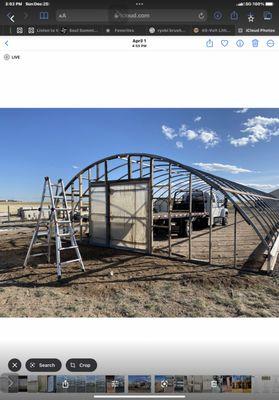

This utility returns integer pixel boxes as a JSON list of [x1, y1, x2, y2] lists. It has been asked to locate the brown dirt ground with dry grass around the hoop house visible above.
[[0, 227, 279, 317]]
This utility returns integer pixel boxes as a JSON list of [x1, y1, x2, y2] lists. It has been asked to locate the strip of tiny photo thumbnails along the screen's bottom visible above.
[[0, 374, 272, 395]]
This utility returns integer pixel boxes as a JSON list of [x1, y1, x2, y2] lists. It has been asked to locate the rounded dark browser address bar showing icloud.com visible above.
[[56, 9, 207, 24]]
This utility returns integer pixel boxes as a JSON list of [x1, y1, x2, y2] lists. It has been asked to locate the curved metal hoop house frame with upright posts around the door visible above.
[[65, 153, 279, 272]]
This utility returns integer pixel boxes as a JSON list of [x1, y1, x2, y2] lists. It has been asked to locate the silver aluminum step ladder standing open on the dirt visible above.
[[24, 177, 85, 280]]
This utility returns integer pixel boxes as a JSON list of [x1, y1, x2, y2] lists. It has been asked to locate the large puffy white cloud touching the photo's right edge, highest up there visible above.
[[230, 116, 279, 147]]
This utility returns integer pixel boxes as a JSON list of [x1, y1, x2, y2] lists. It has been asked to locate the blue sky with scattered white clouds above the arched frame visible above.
[[0, 109, 279, 200]]
